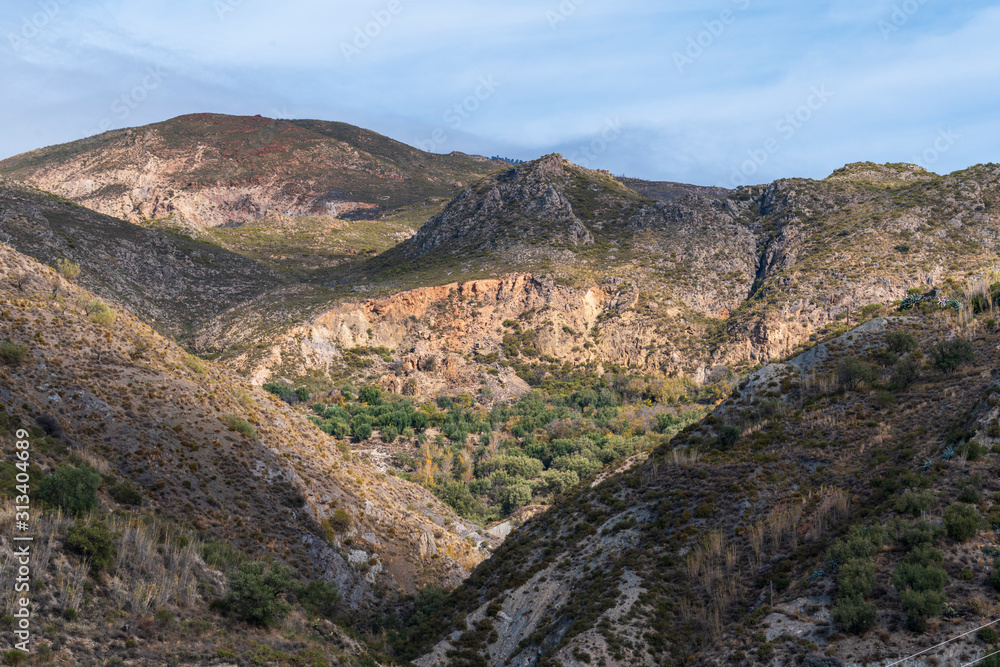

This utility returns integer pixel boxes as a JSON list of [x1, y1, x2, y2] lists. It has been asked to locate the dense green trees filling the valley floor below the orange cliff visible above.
[[300, 374, 711, 524]]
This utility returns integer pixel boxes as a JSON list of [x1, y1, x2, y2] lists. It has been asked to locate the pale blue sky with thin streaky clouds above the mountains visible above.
[[0, 0, 1000, 187]]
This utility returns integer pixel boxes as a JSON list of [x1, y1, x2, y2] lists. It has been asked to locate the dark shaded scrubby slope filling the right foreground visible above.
[[412, 304, 1000, 667]]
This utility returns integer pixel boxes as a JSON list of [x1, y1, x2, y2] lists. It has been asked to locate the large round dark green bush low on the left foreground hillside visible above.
[[223, 561, 295, 626]]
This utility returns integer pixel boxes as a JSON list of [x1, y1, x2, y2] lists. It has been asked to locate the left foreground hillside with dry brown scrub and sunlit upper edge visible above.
[[0, 246, 496, 664]]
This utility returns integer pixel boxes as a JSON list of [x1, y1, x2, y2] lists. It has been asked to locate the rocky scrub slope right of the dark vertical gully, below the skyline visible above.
[[714, 163, 1000, 363]]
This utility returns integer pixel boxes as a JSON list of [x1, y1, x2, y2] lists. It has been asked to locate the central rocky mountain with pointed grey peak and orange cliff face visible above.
[[230, 155, 1000, 404]]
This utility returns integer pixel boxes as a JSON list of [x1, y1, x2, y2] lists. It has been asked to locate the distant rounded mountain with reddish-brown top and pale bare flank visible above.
[[0, 113, 501, 227]]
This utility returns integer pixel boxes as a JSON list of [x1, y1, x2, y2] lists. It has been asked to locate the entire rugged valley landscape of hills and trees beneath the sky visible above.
[[0, 114, 1000, 667]]
